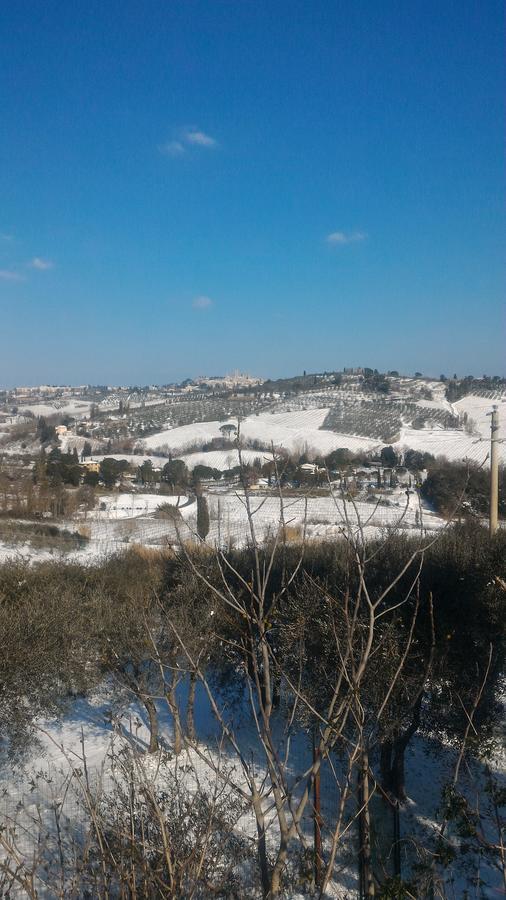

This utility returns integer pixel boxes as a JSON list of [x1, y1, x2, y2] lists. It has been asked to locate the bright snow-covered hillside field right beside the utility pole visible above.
[[393, 425, 506, 464]]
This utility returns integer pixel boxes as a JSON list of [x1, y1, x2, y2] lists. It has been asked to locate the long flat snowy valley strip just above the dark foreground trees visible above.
[[0, 486, 445, 562]]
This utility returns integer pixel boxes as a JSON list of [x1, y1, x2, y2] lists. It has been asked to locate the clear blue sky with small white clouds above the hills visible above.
[[0, 0, 506, 385]]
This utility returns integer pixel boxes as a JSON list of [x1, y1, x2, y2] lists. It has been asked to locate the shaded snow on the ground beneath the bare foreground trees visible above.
[[0, 682, 504, 900]]
